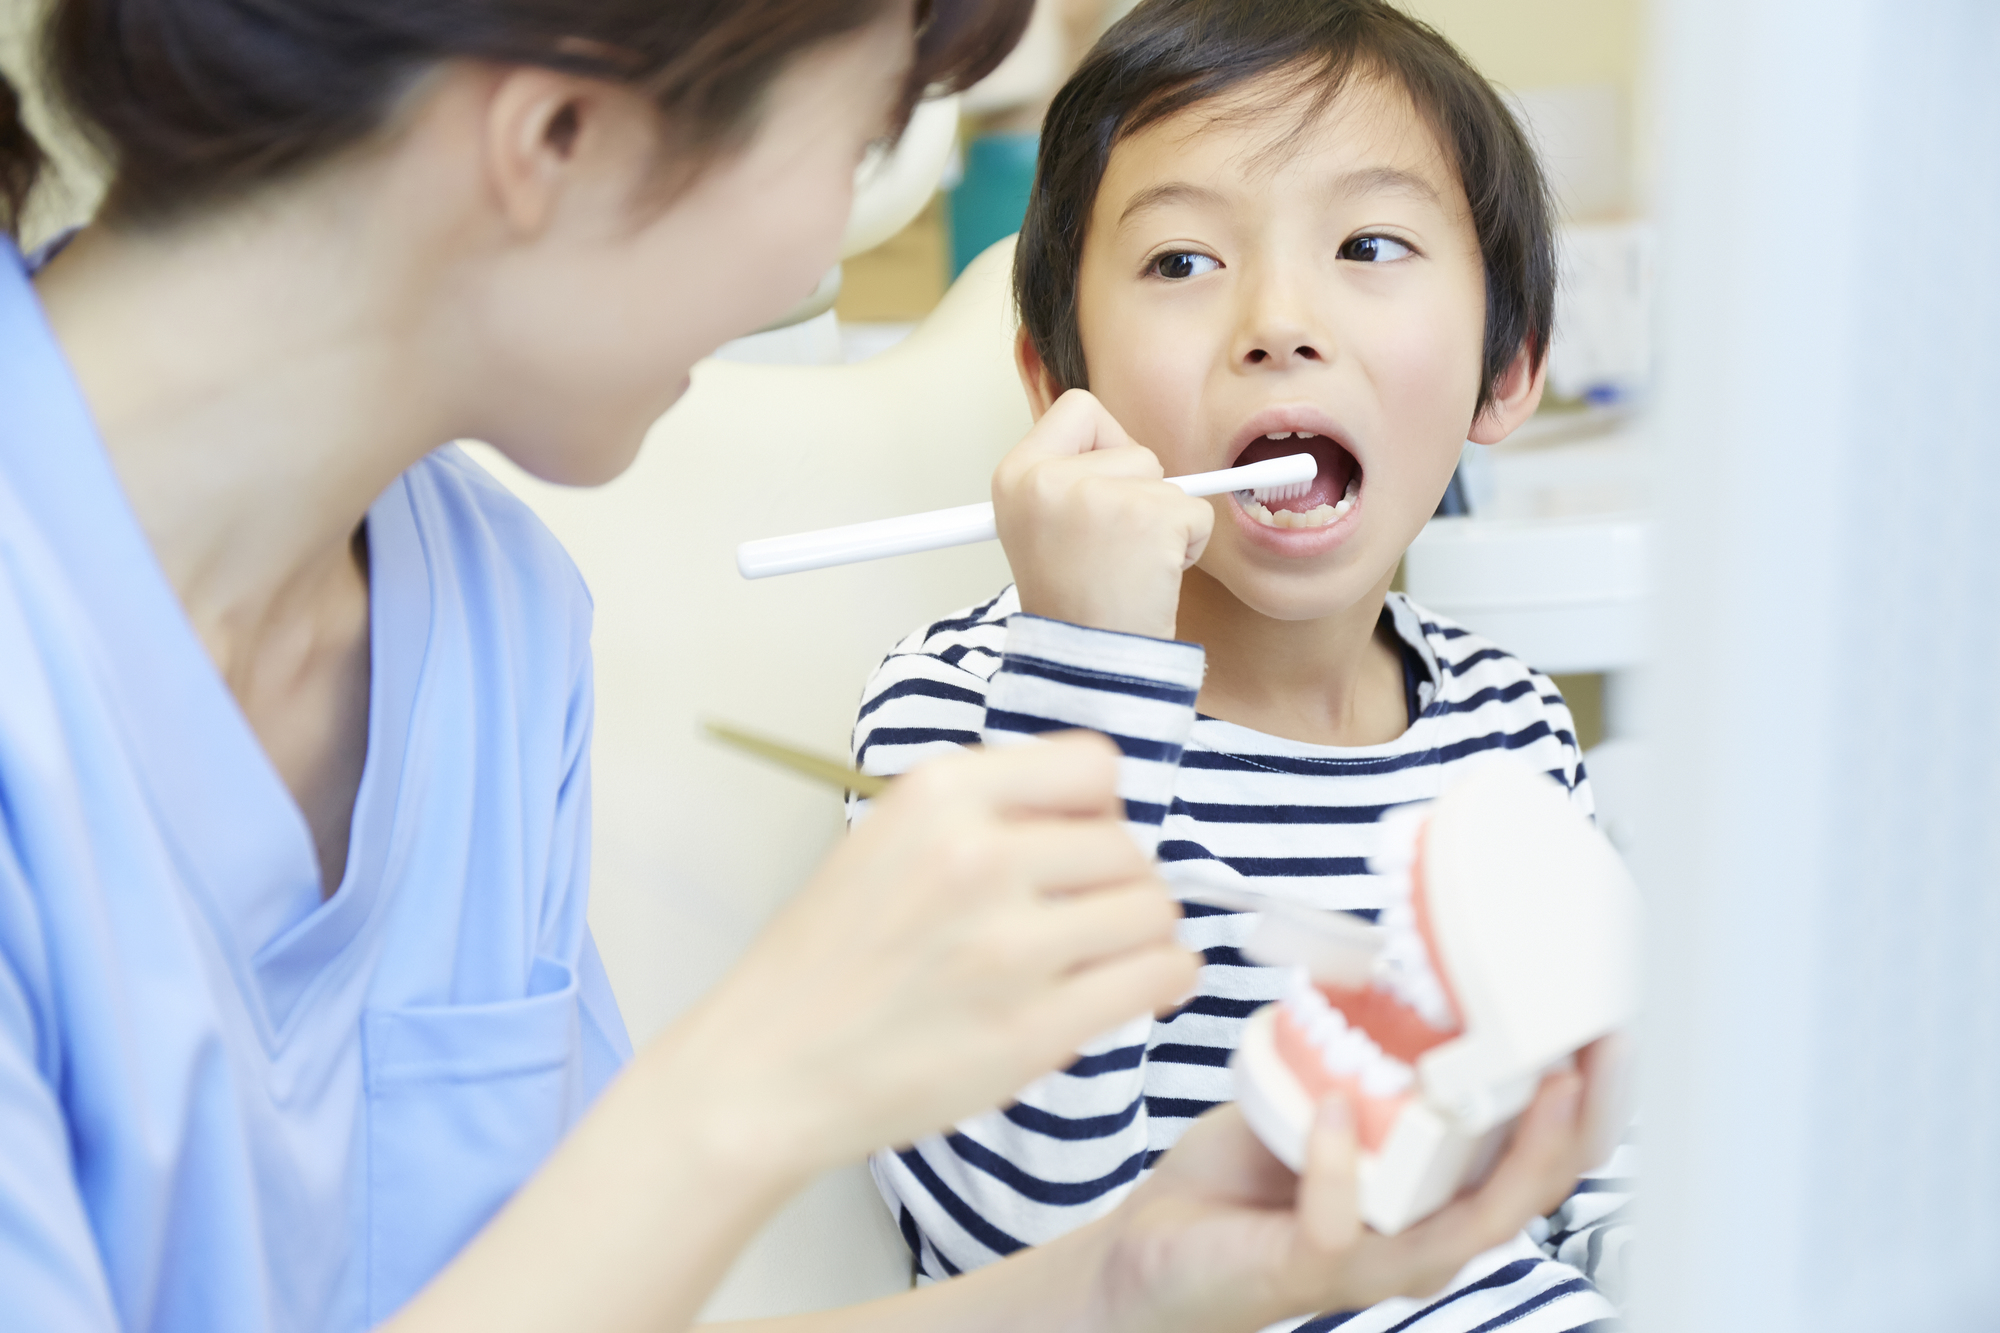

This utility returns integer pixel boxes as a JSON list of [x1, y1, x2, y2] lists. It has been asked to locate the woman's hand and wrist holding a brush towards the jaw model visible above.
[[660, 735, 1198, 1173]]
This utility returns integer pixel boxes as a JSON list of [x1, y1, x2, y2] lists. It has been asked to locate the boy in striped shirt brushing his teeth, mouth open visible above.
[[854, 0, 1620, 1333]]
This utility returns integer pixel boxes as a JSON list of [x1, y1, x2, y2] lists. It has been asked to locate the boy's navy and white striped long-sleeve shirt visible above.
[[850, 588, 1626, 1333]]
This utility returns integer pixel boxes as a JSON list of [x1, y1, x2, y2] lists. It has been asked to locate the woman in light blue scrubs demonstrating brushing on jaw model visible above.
[[0, 0, 1596, 1333]]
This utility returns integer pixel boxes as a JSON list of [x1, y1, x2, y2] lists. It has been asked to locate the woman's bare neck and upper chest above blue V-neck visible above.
[[36, 174, 476, 895]]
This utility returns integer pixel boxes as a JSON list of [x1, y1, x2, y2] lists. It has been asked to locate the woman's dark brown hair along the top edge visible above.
[[0, 0, 1034, 232]]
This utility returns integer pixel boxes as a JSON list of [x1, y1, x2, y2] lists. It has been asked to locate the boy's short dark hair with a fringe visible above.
[[1014, 0, 1556, 410]]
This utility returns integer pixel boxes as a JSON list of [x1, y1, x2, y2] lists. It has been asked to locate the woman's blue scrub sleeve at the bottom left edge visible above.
[[0, 824, 118, 1333]]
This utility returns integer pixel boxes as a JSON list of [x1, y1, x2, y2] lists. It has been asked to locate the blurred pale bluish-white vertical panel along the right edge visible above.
[[1636, 0, 2000, 1333]]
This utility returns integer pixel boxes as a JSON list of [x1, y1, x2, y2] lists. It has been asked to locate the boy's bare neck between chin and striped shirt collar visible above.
[[1178, 566, 1410, 747]]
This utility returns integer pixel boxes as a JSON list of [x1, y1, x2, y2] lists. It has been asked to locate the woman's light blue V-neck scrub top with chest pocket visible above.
[[0, 240, 630, 1333]]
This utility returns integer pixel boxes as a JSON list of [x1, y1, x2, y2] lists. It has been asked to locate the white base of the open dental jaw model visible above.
[[1232, 765, 1638, 1235]]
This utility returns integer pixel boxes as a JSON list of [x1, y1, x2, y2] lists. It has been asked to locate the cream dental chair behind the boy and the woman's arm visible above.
[[468, 226, 1030, 1317]]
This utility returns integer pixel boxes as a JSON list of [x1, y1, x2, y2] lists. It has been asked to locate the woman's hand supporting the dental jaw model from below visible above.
[[1078, 1039, 1620, 1333]]
